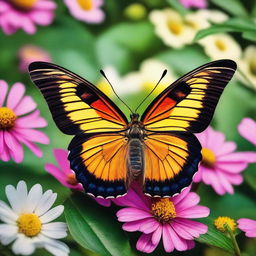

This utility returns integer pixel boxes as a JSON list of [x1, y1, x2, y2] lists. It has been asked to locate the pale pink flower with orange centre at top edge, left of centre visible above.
[[64, 0, 105, 23]]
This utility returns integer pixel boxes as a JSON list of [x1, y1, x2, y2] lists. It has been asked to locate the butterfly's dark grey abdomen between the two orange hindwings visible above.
[[128, 138, 144, 180]]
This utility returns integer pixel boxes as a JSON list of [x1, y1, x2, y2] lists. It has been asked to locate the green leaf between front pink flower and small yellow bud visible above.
[[196, 218, 234, 252]]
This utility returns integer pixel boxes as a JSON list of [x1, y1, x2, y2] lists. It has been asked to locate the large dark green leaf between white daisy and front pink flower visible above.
[[65, 193, 133, 256]]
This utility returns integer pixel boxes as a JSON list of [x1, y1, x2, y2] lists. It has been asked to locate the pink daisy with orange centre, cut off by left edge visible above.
[[0, 80, 49, 163]]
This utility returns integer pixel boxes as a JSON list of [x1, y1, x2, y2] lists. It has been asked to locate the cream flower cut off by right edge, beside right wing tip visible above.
[[238, 45, 256, 89]]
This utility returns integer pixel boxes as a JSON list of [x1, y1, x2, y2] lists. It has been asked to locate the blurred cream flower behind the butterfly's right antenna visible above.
[[124, 59, 175, 95]]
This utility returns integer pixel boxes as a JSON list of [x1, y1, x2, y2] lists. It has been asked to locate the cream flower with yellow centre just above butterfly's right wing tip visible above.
[[198, 34, 242, 60]]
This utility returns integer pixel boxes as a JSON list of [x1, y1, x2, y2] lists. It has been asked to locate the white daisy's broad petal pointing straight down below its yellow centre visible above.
[[12, 235, 36, 255]]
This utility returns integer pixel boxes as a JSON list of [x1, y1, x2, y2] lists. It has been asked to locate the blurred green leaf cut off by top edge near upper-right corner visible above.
[[211, 0, 248, 17]]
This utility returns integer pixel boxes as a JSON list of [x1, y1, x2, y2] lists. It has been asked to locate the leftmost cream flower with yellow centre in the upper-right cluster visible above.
[[149, 9, 195, 48]]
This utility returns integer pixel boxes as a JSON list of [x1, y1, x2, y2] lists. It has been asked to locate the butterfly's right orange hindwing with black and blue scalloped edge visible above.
[[144, 132, 202, 197]]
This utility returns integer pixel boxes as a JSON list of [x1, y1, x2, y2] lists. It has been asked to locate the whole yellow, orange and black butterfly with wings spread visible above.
[[29, 60, 236, 198]]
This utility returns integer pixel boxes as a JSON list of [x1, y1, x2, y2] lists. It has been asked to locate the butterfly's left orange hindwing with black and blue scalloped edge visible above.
[[68, 133, 128, 198]]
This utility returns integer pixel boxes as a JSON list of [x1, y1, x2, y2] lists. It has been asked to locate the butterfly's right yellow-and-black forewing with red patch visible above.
[[141, 60, 236, 133]]
